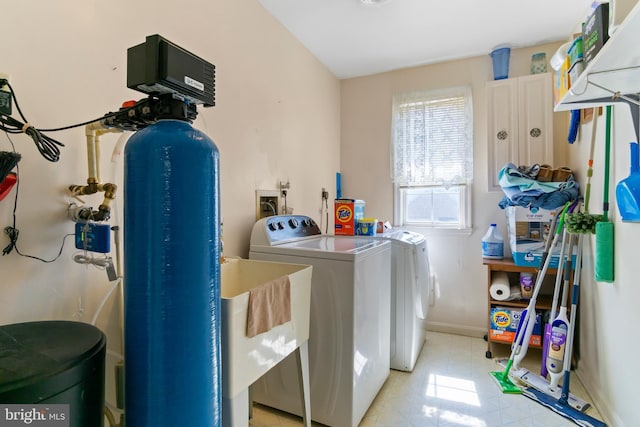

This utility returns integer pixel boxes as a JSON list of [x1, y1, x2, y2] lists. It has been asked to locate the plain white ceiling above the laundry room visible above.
[[258, 0, 593, 79]]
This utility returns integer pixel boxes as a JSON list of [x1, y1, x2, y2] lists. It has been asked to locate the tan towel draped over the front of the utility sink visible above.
[[247, 276, 291, 338]]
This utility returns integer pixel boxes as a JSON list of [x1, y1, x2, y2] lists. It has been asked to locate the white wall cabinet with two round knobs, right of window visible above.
[[486, 73, 553, 190]]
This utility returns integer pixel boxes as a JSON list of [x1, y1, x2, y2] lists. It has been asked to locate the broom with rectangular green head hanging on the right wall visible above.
[[594, 105, 614, 283]]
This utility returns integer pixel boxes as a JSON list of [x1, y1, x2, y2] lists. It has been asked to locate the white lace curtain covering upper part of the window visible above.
[[391, 87, 473, 188]]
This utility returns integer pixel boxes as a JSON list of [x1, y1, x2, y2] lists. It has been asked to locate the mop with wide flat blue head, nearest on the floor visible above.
[[522, 234, 606, 427]]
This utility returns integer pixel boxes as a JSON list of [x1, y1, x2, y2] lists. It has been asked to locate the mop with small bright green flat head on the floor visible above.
[[489, 203, 569, 394]]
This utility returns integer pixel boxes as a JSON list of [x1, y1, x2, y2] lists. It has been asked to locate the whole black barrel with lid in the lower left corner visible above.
[[0, 320, 107, 427]]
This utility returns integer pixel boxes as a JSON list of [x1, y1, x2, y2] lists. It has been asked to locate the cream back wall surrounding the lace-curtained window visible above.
[[341, 43, 567, 336]]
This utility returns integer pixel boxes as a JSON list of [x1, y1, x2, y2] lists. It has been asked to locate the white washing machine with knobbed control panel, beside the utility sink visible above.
[[249, 215, 391, 427]]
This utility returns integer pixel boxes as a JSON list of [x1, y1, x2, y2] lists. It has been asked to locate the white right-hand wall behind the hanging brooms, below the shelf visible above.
[[568, 105, 640, 427]]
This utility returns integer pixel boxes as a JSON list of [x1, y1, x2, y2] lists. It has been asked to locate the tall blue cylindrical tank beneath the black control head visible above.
[[124, 120, 222, 427]]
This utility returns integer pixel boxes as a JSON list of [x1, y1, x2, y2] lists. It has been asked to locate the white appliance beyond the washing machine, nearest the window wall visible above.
[[376, 230, 433, 372]]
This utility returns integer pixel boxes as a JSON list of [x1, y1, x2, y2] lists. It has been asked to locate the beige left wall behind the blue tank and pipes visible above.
[[0, 0, 340, 414]]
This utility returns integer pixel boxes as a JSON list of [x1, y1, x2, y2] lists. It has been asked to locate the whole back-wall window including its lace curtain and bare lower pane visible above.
[[391, 87, 473, 229]]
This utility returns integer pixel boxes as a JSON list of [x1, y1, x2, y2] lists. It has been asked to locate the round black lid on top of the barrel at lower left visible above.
[[0, 320, 106, 403]]
